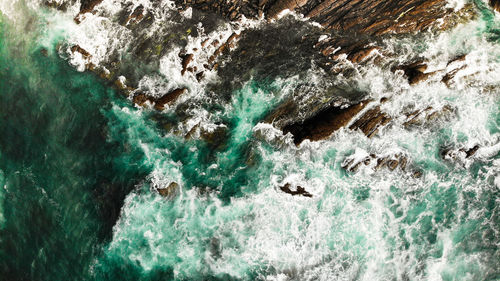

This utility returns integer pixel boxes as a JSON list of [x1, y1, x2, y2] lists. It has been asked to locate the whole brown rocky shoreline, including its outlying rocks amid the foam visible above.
[[45, 0, 500, 185]]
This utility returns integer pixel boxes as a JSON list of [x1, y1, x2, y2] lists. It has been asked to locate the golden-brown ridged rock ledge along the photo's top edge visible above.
[[176, 0, 460, 35]]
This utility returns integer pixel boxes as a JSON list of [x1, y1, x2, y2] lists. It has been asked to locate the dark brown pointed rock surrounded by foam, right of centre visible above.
[[283, 101, 370, 145]]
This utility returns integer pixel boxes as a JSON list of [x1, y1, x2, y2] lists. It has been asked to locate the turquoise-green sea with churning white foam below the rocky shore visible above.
[[0, 2, 500, 280]]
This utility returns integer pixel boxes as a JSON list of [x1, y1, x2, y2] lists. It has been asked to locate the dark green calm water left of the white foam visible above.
[[0, 20, 148, 280]]
